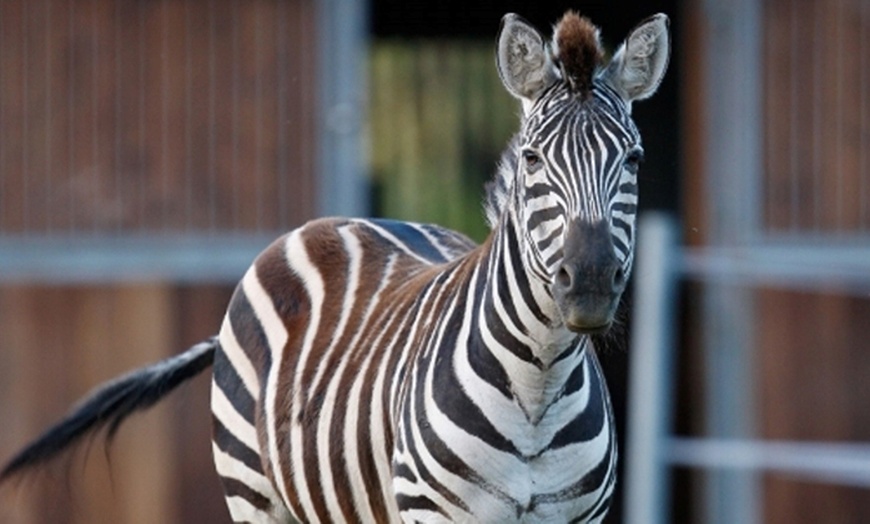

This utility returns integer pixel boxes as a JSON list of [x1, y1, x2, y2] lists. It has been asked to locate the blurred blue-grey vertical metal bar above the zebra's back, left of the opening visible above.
[[317, 0, 369, 216]]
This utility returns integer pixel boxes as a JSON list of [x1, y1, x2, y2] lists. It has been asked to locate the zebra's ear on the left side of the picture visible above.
[[496, 13, 558, 107]]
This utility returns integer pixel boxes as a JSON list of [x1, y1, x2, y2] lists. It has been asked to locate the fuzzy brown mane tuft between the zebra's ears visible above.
[[553, 11, 604, 98]]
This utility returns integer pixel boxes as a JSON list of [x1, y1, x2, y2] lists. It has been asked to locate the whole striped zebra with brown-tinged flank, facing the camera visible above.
[[2, 11, 670, 522]]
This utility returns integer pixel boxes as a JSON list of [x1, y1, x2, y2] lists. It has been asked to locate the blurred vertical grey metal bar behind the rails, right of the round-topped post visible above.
[[700, 0, 764, 524]]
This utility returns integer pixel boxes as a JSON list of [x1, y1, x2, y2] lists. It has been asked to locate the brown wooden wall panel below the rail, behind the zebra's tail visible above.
[[0, 284, 231, 524]]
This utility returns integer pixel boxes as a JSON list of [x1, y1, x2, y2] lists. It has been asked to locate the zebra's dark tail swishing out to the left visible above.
[[0, 337, 219, 481]]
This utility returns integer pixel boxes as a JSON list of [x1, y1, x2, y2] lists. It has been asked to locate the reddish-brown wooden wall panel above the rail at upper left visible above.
[[0, 0, 316, 234]]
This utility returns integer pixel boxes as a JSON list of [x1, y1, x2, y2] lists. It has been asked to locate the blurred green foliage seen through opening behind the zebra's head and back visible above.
[[368, 40, 519, 241]]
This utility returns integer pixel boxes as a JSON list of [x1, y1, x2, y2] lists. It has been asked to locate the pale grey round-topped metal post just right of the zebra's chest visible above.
[[625, 213, 678, 524]]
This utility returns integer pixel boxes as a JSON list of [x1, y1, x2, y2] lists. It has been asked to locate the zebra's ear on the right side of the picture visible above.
[[603, 13, 671, 104]]
